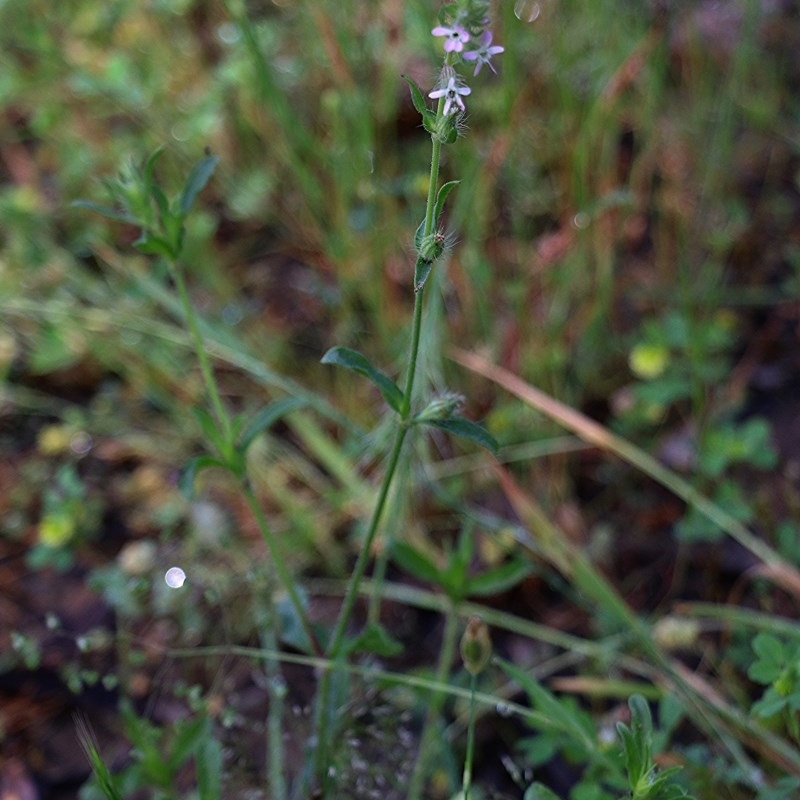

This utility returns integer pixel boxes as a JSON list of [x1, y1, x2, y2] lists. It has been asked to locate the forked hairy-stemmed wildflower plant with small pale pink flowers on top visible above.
[[77, 0, 503, 797]]
